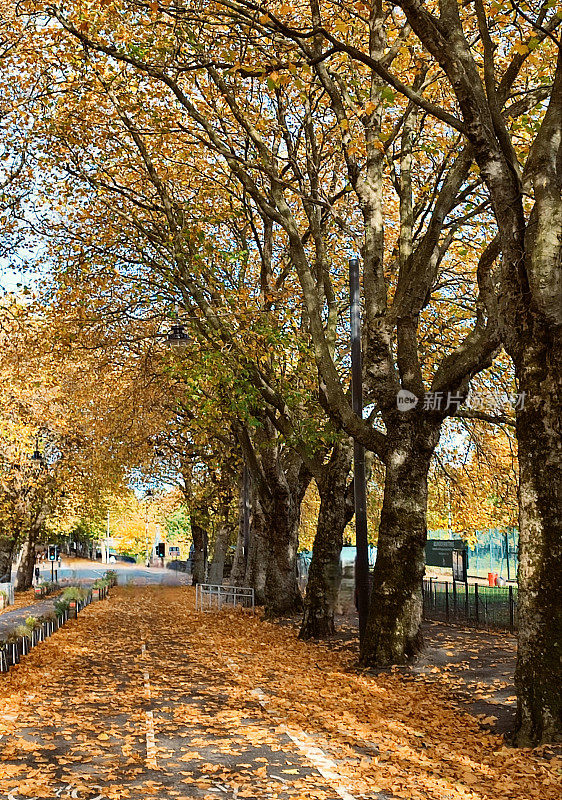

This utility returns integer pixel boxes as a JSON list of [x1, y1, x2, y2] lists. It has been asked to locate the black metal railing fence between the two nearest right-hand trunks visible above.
[[423, 578, 517, 630]]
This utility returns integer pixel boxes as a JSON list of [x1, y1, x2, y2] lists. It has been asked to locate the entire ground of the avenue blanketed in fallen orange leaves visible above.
[[0, 588, 560, 800]]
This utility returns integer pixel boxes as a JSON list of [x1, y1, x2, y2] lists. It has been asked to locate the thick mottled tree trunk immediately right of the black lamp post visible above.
[[361, 418, 440, 667]]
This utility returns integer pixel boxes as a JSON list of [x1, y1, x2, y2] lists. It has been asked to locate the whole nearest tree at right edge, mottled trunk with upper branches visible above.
[[282, 0, 562, 744]]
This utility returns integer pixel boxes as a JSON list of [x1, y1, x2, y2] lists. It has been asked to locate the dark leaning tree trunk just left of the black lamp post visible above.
[[299, 445, 353, 639]]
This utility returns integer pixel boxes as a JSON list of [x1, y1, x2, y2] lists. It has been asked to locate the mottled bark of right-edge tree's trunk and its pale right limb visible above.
[[512, 49, 562, 746]]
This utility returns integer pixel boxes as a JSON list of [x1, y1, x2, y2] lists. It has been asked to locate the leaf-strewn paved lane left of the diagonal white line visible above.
[[0, 590, 353, 800]]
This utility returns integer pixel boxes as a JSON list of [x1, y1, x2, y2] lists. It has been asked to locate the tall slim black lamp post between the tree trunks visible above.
[[349, 258, 369, 639]]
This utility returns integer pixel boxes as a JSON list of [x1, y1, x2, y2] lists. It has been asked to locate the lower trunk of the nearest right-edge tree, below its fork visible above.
[[515, 336, 562, 747]]
